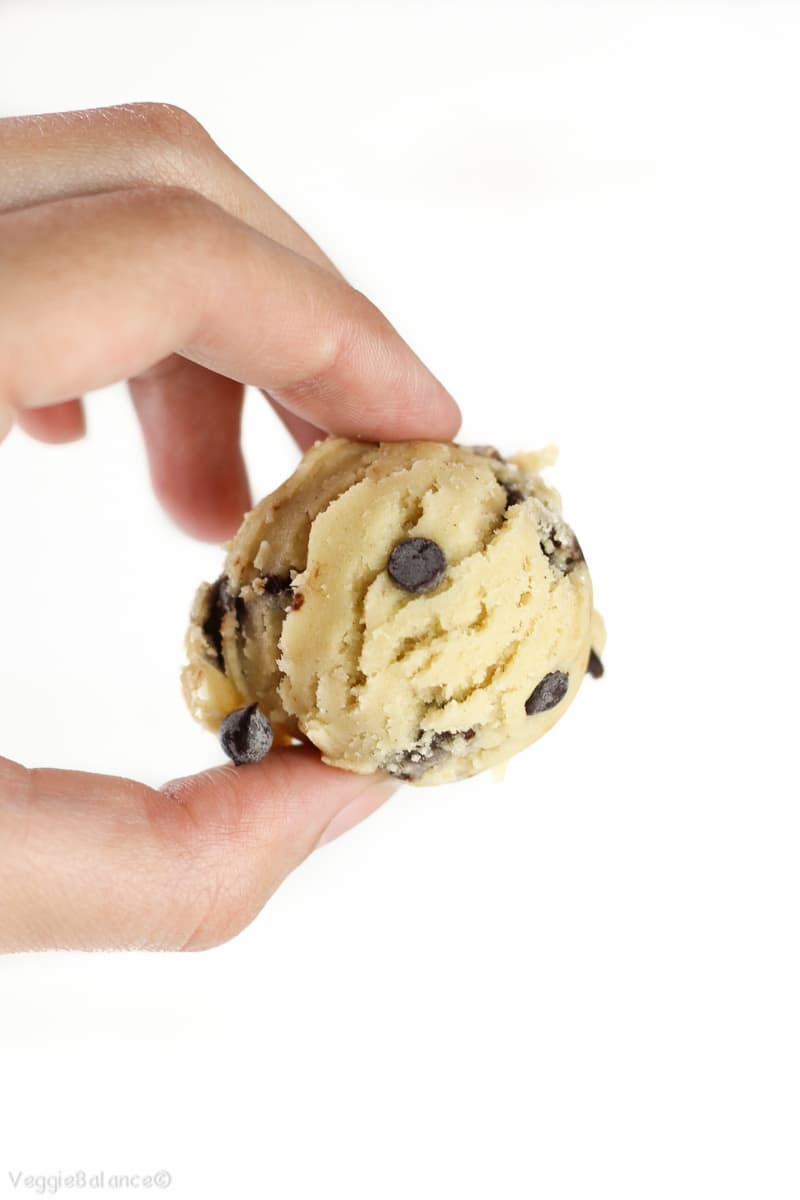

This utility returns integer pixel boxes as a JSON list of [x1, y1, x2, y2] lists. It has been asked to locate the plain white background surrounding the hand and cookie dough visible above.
[[0, 0, 800, 1200]]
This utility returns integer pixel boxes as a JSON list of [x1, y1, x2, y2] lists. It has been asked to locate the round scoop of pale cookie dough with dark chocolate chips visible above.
[[184, 438, 603, 784]]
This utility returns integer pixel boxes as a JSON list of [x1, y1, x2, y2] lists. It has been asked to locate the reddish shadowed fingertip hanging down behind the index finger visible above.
[[130, 355, 251, 541]]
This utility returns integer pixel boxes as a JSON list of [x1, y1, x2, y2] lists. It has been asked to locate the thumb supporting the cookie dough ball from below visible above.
[[0, 748, 395, 952]]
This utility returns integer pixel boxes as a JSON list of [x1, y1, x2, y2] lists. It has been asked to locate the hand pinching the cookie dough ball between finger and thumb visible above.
[[0, 104, 458, 950]]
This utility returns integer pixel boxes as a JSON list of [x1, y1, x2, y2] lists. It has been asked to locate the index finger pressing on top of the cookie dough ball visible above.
[[0, 188, 458, 440]]
